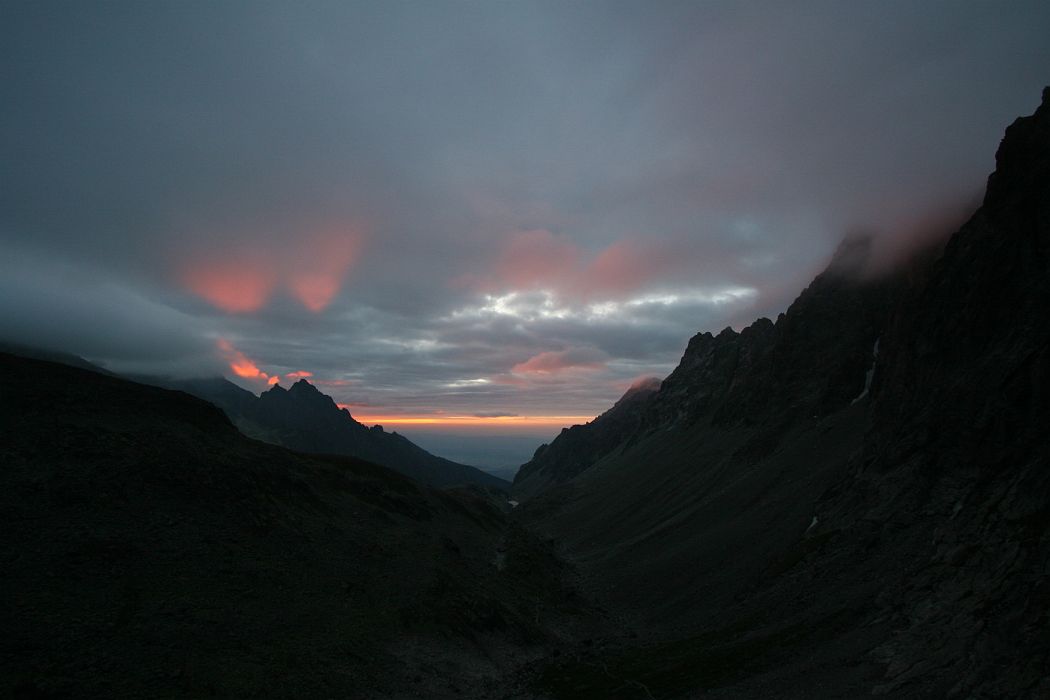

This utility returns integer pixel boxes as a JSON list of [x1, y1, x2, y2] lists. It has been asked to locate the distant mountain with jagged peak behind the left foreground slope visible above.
[[150, 378, 510, 489]]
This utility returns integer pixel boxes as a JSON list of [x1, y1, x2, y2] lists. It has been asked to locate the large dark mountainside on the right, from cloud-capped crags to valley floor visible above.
[[516, 88, 1050, 698]]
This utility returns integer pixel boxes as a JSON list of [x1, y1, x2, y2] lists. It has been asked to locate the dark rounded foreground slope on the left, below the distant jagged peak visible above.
[[0, 354, 600, 698]]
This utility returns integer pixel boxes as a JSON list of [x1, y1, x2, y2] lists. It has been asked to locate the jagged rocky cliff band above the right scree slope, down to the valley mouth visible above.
[[515, 238, 900, 499]]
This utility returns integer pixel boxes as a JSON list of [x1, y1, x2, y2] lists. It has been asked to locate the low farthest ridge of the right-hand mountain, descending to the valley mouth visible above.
[[513, 378, 659, 500]]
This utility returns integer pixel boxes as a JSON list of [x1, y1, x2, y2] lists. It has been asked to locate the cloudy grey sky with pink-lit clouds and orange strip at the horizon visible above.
[[0, 0, 1050, 431]]
